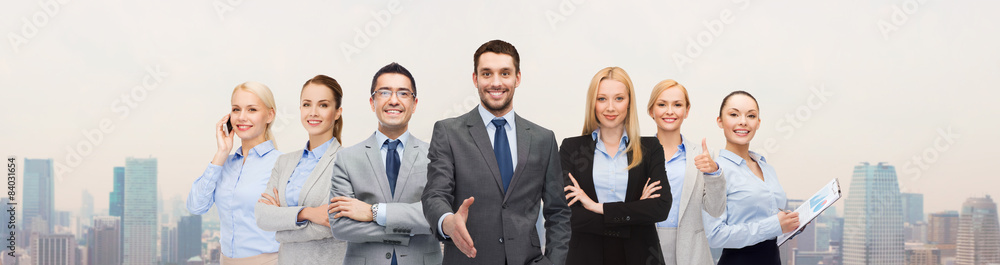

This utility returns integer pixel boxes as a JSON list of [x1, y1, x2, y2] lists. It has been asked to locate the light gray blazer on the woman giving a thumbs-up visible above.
[[658, 137, 726, 265]]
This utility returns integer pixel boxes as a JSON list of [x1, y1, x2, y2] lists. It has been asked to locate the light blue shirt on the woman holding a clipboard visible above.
[[702, 150, 787, 248]]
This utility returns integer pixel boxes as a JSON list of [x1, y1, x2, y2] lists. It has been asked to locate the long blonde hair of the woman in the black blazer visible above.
[[582, 67, 642, 169]]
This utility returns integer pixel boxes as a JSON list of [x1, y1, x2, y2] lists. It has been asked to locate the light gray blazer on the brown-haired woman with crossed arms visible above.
[[254, 140, 346, 264]]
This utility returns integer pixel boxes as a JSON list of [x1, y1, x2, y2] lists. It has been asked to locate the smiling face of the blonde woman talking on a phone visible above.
[[229, 90, 274, 142]]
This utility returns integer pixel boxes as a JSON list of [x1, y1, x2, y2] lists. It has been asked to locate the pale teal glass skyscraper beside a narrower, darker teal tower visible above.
[[122, 157, 159, 264]]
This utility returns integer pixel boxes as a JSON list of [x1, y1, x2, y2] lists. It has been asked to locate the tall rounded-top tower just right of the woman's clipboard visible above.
[[843, 162, 905, 265]]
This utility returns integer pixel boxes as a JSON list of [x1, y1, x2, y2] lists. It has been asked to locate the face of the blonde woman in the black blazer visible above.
[[594, 79, 631, 130]]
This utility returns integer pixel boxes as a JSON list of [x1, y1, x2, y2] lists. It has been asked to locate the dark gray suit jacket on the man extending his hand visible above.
[[421, 109, 570, 265]]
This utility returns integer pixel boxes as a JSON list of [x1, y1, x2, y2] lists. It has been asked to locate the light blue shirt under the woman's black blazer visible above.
[[590, 128, 628, 203]]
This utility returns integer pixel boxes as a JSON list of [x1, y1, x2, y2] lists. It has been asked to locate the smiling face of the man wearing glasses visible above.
[[368, 73, 417, 131]]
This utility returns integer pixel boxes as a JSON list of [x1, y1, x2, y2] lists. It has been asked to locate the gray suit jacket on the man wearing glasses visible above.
[[330, 133, 441, 265]]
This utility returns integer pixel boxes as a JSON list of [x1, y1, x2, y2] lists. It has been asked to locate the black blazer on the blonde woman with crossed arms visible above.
[[559, 135, 672, 264]]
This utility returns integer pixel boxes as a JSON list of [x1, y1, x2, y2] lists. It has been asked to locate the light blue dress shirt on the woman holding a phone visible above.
[[187, 141, 282, 258]]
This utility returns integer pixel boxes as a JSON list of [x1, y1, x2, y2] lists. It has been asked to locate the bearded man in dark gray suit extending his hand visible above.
[[421, 40, 570, 265]]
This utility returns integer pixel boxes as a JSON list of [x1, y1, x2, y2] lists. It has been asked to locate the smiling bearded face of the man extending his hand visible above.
[[472, 52, 521, 116]]
